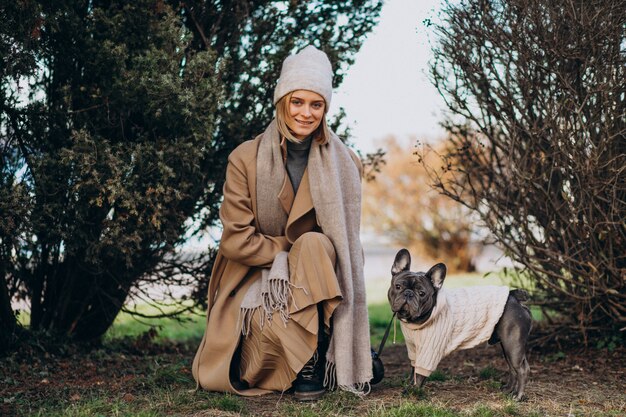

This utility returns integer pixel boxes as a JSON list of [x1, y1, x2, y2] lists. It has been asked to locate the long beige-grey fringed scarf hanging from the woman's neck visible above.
[[242, 120, 372, 393]]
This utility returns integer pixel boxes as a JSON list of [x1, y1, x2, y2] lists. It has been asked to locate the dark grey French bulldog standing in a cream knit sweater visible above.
[[387, 249, 531, 401]]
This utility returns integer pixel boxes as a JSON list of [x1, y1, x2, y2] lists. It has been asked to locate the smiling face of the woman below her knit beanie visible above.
[[285, 90, 326, 139]]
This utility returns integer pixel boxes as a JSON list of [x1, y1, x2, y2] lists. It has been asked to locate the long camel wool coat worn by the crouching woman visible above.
[[192, 135, 363, 395]]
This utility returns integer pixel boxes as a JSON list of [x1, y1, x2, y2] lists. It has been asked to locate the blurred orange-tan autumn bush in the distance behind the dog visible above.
[[363, 137, 482, 272]]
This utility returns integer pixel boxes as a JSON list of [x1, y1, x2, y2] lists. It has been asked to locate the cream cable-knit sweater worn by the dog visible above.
[[400, 286, 509, 376]]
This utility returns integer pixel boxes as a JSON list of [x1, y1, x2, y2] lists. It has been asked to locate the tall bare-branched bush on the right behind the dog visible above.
[[422, 0, 626, 336]]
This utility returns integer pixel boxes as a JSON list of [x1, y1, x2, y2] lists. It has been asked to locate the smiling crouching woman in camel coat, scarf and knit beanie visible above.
[[193, 46, 372, 400]]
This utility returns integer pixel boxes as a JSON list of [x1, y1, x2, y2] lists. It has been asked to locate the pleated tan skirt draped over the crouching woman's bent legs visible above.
[[239, 232, 341, 391]]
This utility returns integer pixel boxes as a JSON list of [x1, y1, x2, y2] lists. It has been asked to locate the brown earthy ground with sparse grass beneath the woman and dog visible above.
[[0, 338, 626, 417]]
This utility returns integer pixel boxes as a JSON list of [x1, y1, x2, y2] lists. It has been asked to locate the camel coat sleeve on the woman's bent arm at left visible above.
[[220, 148, 290, 267]]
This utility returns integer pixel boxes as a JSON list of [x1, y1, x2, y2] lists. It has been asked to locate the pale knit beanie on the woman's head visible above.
[[274, 45, 333, 109]]
